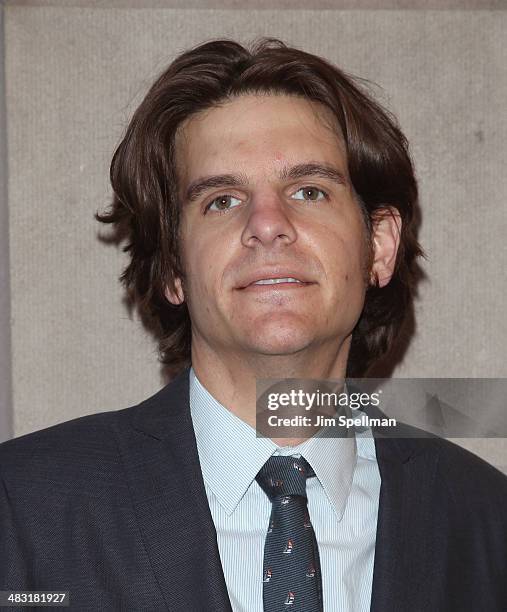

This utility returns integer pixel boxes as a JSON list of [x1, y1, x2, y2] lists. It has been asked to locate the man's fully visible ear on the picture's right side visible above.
[[370, 206, 401, 287]]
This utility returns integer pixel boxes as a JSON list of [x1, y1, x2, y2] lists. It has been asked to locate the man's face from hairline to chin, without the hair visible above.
[[166, 95, 367, 355]]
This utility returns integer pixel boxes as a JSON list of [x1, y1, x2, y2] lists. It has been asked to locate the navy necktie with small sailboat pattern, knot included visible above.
[[256, 455, 323, 612]]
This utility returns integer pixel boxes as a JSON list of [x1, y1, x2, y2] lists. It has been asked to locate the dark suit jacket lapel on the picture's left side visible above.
[[112, 368, 231, 612]]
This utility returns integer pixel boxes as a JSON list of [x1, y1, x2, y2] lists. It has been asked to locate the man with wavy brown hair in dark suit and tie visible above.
[[0, 40, 507, 612]]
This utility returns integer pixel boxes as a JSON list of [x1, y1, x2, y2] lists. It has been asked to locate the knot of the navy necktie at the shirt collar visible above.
[[255, 455, 315, 501]]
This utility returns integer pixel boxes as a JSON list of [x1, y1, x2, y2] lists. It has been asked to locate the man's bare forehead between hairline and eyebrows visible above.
[[175, 94, 345, 181]]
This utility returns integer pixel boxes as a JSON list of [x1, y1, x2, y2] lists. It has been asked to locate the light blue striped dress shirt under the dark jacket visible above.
[[189, 368, 380, 612]]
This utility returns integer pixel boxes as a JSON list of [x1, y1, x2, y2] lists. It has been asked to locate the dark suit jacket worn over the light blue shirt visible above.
[[0, 369, 507, 612]]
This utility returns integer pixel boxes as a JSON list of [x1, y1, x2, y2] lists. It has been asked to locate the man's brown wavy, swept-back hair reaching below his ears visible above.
[[96, 38, 424, 377]]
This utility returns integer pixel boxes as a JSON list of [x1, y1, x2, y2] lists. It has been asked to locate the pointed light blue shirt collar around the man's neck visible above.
[[189, 368, 357, 520]]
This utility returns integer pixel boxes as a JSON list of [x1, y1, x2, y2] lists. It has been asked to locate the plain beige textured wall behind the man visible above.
[[0, 0, 507, 472]]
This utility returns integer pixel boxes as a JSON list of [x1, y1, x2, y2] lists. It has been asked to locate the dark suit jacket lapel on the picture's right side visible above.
[[371, 415, 442, 612]]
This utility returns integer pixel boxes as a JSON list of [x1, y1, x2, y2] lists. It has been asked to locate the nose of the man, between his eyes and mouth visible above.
[[241, 195, 297, 248]]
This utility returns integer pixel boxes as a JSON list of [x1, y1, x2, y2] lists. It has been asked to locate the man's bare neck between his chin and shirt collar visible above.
[[192, 336, 351, 446]]
